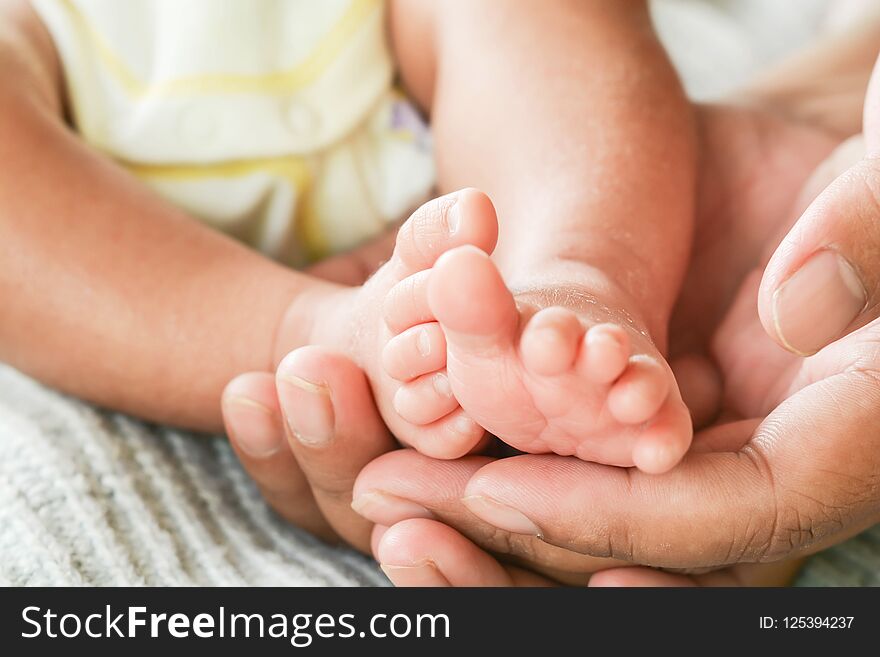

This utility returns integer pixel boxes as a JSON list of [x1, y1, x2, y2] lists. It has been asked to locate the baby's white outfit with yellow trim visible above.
[[32, 0, 434, 266]]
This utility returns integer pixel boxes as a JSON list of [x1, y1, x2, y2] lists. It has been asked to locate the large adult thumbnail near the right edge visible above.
[[773, 250, 868, 356]]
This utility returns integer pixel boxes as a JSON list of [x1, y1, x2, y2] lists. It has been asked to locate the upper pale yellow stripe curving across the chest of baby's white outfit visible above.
[[60, 0, 382, 99]]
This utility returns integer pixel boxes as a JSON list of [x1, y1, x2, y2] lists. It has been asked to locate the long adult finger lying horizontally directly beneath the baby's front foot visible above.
[[465, 370, 880, 568]]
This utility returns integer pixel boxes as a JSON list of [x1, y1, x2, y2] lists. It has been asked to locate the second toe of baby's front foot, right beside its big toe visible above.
[[520, 307, 584, 376]]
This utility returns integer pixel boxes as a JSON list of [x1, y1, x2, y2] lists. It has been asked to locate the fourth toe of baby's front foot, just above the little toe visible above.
[[608, 356, 672, 424]]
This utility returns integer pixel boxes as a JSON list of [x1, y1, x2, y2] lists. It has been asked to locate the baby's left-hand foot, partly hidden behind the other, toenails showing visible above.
[[312, 190, 498, 458]]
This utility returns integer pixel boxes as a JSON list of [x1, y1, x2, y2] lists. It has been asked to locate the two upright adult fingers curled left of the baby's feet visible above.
[[223, 347, 398, 551]]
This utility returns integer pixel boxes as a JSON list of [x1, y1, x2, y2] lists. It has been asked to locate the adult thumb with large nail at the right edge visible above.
[[758, 55, 880, 355]]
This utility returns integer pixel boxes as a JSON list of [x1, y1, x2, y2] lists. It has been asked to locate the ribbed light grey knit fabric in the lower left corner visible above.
[[0, 366, 387, 586]]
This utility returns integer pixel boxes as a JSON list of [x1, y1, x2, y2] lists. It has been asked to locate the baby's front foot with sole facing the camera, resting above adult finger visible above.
[[385, 241, 692, 472]]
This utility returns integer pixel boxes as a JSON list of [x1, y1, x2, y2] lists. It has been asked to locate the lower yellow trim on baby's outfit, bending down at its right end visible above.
[[120, 157, 331, 262]]
